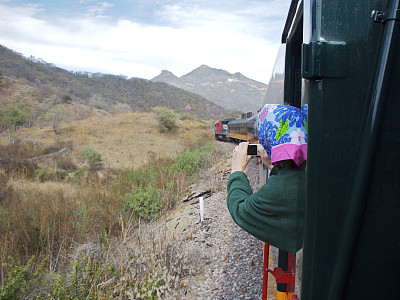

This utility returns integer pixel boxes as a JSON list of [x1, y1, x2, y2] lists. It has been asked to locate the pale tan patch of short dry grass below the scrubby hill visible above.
[[0, 113, 209, 170]]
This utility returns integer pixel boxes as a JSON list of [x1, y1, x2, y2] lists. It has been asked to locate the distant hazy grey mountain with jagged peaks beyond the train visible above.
[[152, 65, 267, 112]]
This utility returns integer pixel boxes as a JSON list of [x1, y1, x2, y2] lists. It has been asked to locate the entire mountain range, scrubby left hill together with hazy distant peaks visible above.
[[0, 45, 267, 123]]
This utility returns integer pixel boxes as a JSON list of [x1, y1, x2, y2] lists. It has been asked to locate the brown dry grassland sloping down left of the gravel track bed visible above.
[[0, 113, 219, 299]]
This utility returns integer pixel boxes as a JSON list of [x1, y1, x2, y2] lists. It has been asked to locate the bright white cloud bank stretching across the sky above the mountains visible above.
[[0, 0, 290, 82]]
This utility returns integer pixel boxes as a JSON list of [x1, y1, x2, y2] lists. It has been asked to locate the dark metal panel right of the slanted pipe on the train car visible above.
[[345, 50, 400, 299]]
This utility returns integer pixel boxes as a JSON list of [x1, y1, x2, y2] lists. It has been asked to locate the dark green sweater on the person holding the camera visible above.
[[227, 164, 305, 254]]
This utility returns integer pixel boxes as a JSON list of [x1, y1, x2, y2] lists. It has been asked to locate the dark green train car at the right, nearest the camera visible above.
[[266, 0, 400, 300]]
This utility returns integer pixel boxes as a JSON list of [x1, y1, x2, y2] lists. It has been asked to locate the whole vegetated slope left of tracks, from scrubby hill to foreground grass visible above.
[[0, 46, 234, 300]]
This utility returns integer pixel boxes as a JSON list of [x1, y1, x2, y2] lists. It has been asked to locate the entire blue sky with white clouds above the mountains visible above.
[[0, 0, 291, 83]]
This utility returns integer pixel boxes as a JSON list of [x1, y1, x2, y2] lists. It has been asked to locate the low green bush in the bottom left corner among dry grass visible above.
[[0, 252, 109, 300]]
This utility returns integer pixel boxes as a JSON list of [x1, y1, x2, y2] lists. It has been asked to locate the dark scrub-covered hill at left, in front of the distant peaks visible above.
[[0, 46, 226, 124]]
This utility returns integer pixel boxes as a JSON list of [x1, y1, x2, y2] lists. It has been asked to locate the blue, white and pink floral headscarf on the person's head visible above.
[[258, 104, 308, 166]]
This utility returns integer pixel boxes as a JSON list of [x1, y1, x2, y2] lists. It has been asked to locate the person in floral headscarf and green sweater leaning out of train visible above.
[[227, 104, 307, 254]]
